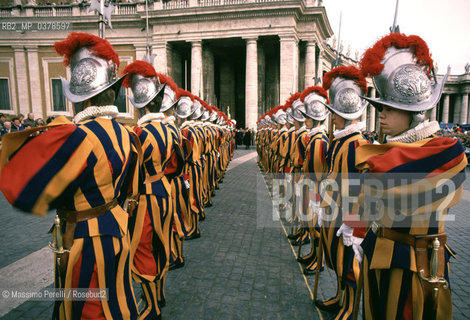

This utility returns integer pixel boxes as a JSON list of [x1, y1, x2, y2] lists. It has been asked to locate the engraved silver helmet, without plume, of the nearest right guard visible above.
[[363, 46, 447, 112]]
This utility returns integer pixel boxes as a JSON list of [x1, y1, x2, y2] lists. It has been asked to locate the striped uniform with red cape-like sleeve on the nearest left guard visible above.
[[0, 117, 138, 319]]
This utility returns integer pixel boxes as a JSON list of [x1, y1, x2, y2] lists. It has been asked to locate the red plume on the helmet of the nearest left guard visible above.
[[54, 32, 119, 67]]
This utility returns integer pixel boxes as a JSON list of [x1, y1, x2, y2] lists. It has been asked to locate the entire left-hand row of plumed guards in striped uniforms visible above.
[[0, 33, 235, 319]]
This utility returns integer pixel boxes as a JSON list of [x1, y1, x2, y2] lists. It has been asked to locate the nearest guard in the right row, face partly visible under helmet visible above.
[[354, 33, 467, 319]]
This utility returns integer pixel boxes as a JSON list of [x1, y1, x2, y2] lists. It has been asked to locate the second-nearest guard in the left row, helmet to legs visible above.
[[123, 61, 181, 319]]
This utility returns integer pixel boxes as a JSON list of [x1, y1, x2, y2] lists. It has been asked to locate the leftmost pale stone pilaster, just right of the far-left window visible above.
[[12, 46, 31, 117]]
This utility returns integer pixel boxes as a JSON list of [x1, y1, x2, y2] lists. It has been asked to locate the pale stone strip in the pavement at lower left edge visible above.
[[0, 247, 54, 317]]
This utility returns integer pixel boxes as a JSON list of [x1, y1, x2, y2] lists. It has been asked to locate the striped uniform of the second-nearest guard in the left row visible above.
[[130, 114, 175, 319]]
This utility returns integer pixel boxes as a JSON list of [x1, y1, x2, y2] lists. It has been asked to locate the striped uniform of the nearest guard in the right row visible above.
[[357, 138, 467, 319]]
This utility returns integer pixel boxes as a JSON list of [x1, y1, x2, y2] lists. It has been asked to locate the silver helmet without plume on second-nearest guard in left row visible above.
[[128, 73, 165, 109]]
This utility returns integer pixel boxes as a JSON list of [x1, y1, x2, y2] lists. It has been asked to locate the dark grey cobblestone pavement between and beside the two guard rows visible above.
[[0, 149, 470, 320]]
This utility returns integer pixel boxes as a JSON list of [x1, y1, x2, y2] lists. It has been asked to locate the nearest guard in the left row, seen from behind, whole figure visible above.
[[0, 32, 139, 319]]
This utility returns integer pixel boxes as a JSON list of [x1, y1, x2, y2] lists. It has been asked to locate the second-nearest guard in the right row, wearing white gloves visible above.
[[316, 66, 368, 319]]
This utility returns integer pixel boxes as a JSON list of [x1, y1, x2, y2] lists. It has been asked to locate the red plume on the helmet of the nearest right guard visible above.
[[360, 33, 433, 77]]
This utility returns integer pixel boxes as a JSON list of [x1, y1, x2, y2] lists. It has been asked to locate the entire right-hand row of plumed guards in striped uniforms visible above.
[[256, 33, 467, 319]]
